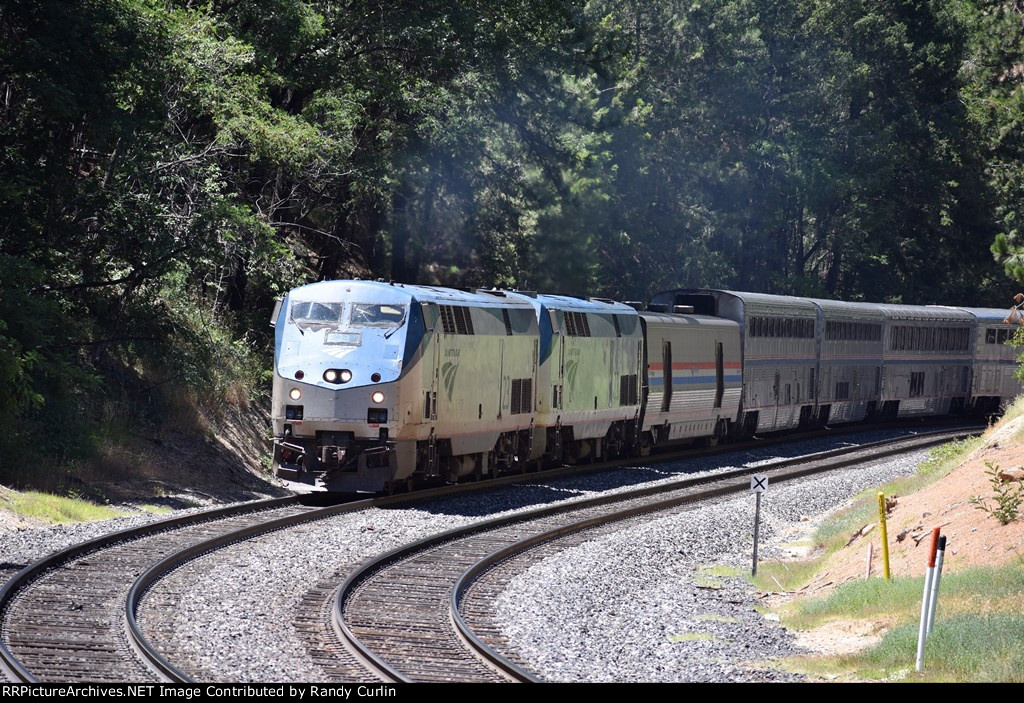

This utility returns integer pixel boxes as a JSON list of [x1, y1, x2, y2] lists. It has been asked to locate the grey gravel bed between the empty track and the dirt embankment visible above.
[[498, 452, 927, 682]]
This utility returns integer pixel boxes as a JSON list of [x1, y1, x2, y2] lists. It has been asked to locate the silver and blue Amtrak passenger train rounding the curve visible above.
[[271, 280, 1021, 493]]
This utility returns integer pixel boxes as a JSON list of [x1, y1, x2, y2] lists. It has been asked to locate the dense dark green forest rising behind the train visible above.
[[0, 0, 1024, 480]]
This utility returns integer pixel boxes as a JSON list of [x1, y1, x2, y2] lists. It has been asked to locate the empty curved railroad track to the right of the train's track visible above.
[[334, 425, 970, 683]]
